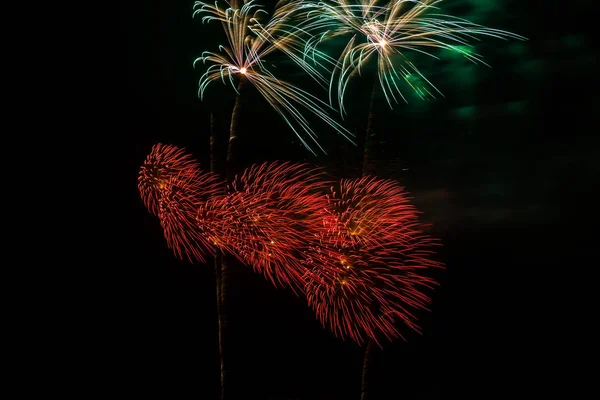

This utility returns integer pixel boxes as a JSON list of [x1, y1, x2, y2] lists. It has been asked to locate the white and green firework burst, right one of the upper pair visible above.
[[302, 0, 525, 114]]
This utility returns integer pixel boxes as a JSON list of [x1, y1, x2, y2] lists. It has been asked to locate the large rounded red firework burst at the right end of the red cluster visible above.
[[305, 177, 442, 344]]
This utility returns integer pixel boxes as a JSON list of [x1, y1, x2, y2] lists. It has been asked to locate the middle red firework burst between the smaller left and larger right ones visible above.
[[198, 162, 327, 292]]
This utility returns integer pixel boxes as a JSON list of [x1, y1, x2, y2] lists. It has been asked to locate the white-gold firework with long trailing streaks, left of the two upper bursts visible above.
[[194, 1, 353, 154]]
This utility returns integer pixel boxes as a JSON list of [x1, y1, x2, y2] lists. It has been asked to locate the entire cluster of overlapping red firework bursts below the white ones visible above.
[[138, 144, 442, 344]]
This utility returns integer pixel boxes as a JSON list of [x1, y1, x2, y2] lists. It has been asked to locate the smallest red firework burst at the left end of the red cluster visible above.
[[138, 144, 225, 262]]
